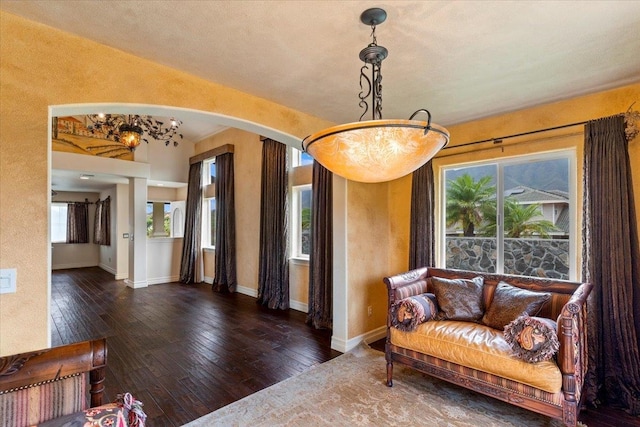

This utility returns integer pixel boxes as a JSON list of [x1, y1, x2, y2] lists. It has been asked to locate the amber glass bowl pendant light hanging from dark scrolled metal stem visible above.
[[302, 8, 449, 182]]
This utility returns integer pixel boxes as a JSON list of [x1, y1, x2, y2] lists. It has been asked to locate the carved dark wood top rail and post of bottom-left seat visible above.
[[0, 338, 107, 407]]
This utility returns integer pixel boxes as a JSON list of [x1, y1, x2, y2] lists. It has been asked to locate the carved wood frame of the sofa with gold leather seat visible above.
[[384, 267, 593, 427]]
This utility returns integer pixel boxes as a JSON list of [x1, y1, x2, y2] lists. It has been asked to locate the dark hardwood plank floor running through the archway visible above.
[[51, 267, 640, 427]]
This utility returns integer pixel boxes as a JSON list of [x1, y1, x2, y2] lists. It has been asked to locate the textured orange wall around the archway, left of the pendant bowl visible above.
[[0, 12, 331, 355]]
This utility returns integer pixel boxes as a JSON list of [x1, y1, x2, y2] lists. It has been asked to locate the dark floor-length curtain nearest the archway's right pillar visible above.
[[307, 161, 333, 329]]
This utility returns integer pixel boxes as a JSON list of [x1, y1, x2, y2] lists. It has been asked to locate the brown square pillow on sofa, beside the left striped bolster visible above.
[[431, 276, 484, 322]]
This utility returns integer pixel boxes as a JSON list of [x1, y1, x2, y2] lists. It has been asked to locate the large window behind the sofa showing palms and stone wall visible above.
[[441, 152, 575, 279]]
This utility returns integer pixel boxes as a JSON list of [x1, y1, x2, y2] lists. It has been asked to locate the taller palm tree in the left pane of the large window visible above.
[[447, 173, 496, 237]]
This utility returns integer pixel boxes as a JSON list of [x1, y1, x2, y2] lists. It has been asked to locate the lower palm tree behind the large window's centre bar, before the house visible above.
[[481, 197, 557, 239]]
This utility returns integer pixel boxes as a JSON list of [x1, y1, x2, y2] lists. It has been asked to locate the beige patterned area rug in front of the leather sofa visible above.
[[186, 345, 580, 427]]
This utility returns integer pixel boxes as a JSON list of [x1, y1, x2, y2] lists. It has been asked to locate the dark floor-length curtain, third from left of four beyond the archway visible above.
[[258, 139, 289, 310]]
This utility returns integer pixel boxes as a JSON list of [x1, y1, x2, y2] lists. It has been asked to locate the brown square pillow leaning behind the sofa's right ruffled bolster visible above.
[[482, 282, 551, 330]]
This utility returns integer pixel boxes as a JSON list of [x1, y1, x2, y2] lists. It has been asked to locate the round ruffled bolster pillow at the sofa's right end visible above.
[[504, 313, 560, 363]]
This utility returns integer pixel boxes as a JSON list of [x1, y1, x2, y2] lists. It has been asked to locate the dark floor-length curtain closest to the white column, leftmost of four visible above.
[[180, 162, 204, 283]]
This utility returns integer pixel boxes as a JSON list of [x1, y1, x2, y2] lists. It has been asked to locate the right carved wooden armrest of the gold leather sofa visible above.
[[558, 283, 593, 402]]
